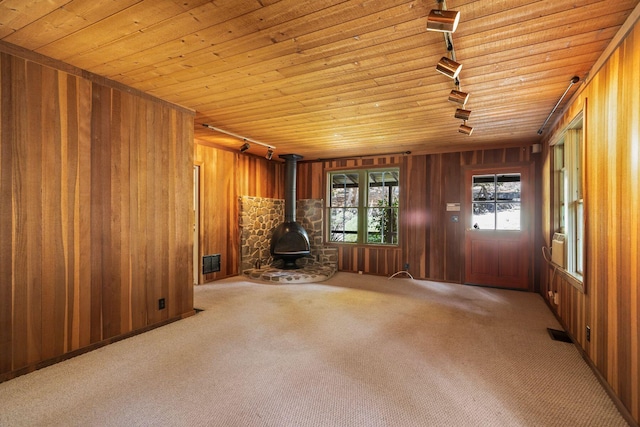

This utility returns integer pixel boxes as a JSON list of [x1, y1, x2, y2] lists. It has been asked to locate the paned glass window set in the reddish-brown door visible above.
[[471, 173, 521, 230]]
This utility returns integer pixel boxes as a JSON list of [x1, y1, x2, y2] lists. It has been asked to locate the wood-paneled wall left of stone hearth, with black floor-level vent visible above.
[[195, 143, 285, 283]]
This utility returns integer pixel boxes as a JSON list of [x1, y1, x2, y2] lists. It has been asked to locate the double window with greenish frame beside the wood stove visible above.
[[327, 168, 400, 245]]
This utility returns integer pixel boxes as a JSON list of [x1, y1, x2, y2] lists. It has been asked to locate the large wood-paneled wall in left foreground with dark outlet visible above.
[[0, 53, 194, 381]]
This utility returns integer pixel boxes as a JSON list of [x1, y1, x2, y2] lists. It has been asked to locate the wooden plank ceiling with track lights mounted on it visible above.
[[0, 0, 639, 160]]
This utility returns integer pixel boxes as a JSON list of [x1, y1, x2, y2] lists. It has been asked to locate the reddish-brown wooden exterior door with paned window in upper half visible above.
[[464, 165, 534, 290]]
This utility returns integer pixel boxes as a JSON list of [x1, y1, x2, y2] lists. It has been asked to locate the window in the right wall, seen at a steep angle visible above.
[[553, 115, 584, 280]]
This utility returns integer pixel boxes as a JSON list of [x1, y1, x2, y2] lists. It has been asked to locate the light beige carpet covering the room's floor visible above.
[[0, 273, 627, 426]]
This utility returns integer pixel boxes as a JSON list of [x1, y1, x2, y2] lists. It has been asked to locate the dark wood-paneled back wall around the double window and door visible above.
[[298, 147, 539, 283]]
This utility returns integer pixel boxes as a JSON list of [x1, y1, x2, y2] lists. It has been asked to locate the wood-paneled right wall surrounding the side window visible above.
[[541, 19, 640, 423]]
